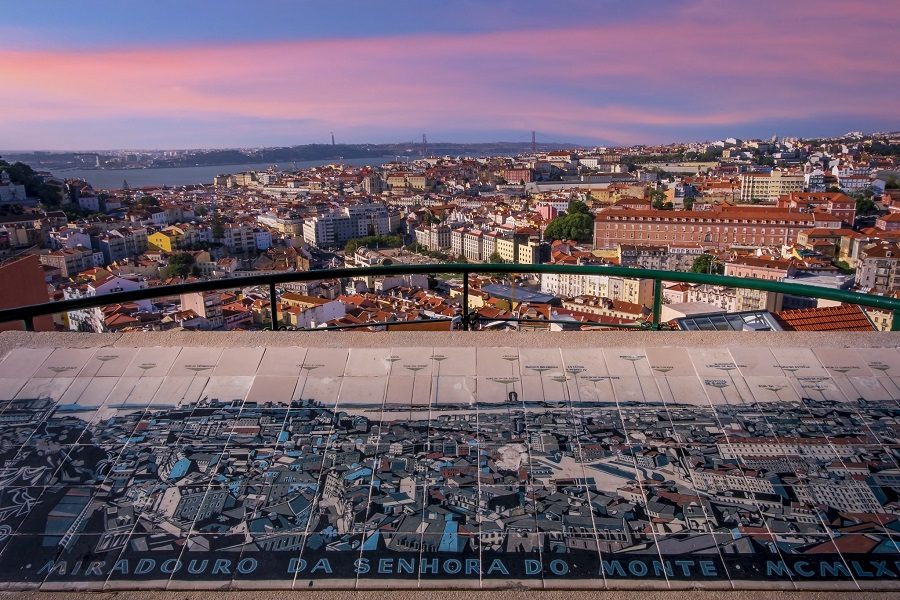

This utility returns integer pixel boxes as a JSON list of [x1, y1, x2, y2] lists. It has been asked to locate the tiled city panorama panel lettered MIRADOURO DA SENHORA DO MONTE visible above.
[[0, 347, 900, 590]]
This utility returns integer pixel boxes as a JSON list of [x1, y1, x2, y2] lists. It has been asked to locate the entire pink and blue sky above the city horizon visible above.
[[0, 0, 900, 149]]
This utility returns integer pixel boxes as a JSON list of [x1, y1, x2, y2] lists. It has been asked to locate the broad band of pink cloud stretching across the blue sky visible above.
[[0, 3, 900, 142]]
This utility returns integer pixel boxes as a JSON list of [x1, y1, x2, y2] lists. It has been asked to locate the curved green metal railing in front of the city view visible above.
[[0, 263, 900, 331]]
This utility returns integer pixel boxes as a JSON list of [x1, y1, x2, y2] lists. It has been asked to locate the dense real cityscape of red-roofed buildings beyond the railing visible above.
[[0, 132, 900, 332]]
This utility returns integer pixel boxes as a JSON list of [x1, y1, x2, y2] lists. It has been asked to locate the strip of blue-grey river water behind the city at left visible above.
[[51, 157, 393, 190]]
